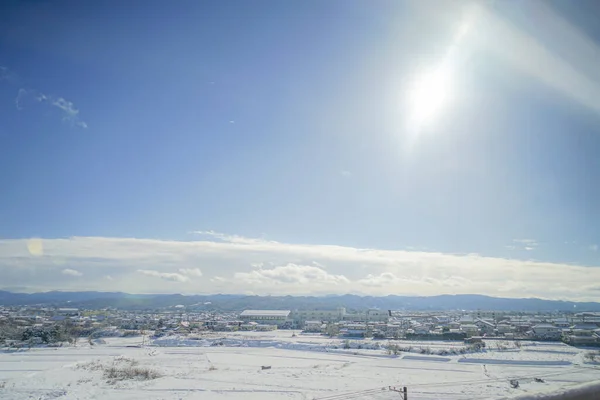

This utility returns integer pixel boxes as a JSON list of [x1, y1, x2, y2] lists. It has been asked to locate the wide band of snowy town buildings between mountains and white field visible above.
[[0, 306, 600, 346]]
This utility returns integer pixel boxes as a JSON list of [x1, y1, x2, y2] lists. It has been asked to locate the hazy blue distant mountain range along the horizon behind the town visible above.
[[0, 291, 600, 312]]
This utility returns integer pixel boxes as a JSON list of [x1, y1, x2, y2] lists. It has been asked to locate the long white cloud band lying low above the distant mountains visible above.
[[0, 232, 600, 300]]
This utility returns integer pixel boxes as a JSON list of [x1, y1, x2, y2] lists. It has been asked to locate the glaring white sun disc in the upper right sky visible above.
[[408, 67, 451, 126]]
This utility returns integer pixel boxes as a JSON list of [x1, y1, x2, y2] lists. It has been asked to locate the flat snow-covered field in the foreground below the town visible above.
[[0, 331, 600, 400]]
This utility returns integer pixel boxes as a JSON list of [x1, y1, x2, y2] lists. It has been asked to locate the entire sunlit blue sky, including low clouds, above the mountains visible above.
[[0, 1, 600, 298]]
